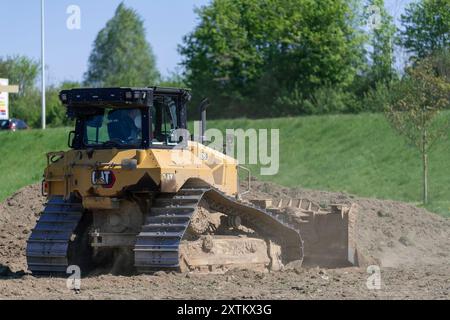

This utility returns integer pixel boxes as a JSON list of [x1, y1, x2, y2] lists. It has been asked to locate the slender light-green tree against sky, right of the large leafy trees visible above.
[[367, 0, 397, 86]]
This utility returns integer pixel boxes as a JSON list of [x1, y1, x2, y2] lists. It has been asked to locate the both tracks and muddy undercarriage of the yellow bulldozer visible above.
[[27, 185, 303, 274]]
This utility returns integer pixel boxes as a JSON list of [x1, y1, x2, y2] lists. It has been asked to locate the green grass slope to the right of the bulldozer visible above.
[[210, 114, 450, 217]]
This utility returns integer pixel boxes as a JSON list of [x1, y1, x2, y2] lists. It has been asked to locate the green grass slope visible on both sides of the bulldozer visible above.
[[0, 114, 450, 216]]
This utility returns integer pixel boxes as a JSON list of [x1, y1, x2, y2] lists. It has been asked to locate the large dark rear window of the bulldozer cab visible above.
[[83, 108, 142, 148]]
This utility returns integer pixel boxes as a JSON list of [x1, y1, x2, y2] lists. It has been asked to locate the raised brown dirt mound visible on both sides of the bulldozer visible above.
[[0, 181, 450, 271]]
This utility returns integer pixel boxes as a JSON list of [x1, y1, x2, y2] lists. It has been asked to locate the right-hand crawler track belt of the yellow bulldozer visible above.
[[134, 187, 303, 273]]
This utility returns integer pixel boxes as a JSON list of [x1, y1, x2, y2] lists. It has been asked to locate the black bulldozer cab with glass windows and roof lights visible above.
[[60, 87, 190, 149]]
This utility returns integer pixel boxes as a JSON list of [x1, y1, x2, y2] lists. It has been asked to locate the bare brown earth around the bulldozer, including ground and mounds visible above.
[[0, 182, 450, 299]]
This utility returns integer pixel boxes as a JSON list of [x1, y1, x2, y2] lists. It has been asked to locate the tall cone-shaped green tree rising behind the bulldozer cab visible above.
[[85, 3, 159, 86]]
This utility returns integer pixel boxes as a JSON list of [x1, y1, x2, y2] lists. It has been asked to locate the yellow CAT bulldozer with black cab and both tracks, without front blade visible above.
[[26, 87, 356, 274]]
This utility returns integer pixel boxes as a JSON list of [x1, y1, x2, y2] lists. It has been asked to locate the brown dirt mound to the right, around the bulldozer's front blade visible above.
[[245, 181, 450, 267]]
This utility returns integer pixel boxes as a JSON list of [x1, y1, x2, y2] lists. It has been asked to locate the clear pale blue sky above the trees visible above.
[[0, 0, 410, 84]]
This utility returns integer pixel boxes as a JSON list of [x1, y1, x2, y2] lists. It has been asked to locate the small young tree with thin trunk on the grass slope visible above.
[[386, 52, 450, 204]]
